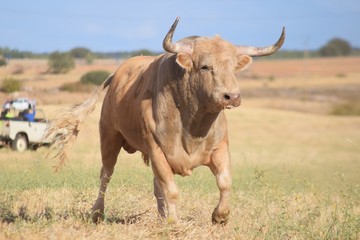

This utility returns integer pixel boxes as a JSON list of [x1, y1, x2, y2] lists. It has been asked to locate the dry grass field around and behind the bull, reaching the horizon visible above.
[[0, 58, 360, 239]]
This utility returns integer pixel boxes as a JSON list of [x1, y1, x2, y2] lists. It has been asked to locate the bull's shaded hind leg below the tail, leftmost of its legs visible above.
[[92, 128, 124, 222]]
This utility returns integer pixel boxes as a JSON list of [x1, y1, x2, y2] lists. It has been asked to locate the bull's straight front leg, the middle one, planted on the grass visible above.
[[151, 152, 179, 224]]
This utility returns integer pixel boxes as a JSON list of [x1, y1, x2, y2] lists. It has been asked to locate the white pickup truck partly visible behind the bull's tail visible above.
[[0, 109, 52, 152]]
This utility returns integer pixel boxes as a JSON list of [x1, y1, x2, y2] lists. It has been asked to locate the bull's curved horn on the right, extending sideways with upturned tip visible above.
[[237, 27, 285, 57]]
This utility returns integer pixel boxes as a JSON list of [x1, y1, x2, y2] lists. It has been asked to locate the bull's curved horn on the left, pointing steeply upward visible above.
[[163, 17, 193, 54]]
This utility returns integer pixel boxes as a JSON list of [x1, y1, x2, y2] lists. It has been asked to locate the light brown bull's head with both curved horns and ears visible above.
[[163, 18, 285, 111]]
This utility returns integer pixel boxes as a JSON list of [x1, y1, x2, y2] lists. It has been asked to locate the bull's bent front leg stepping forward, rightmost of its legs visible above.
[[209, 142, 232, 224]]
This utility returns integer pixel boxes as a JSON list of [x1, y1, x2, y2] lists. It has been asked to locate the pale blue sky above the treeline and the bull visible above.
[[0, 0, 360, 52]]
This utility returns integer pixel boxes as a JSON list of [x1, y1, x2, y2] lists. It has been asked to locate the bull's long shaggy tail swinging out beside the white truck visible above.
[[43, 74, 114, 171]]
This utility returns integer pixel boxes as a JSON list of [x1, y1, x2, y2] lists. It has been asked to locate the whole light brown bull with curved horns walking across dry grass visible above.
[[49, 18, 285, 224]]
